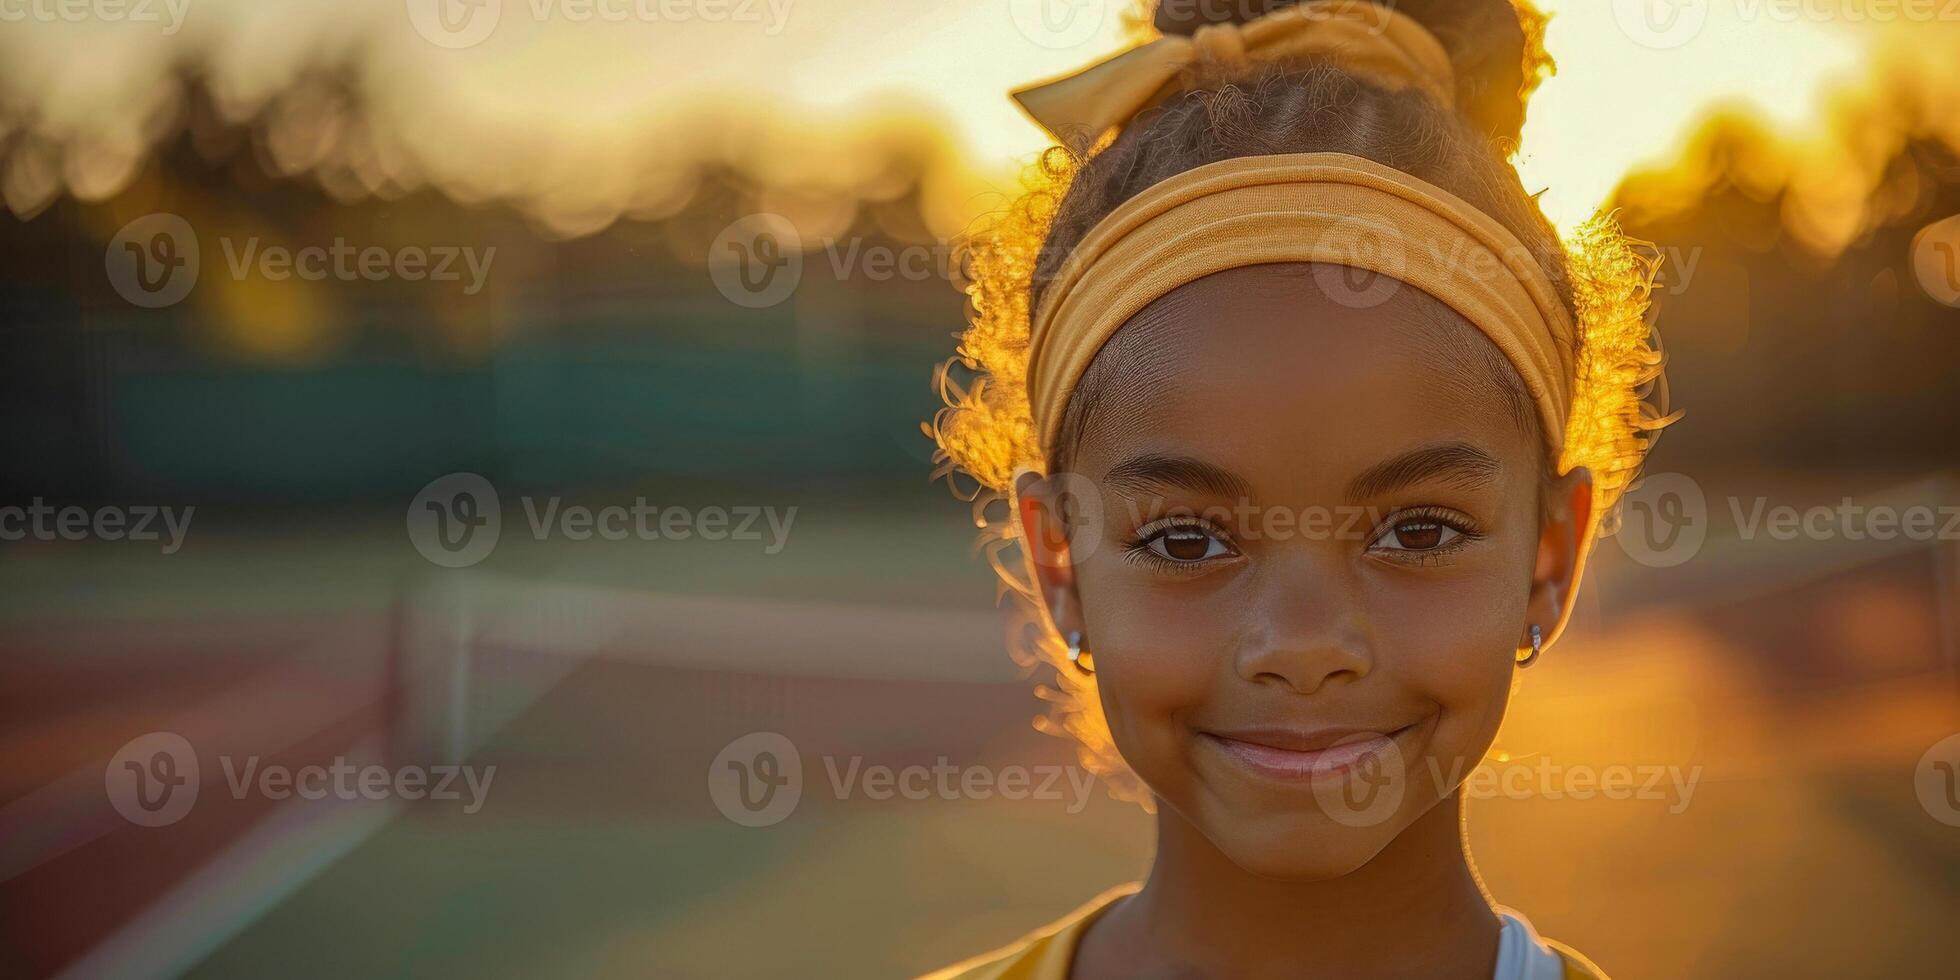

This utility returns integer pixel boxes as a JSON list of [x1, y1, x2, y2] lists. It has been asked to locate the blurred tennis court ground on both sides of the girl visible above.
[[0, 468, 1960, 978]]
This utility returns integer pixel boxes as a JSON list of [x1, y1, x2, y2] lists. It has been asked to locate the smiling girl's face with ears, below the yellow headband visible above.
[[1021, 265, 1592, 878]]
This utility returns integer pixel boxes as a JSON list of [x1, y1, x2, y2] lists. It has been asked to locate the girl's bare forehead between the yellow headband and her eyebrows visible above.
[[1076, 263, 1537, 492]]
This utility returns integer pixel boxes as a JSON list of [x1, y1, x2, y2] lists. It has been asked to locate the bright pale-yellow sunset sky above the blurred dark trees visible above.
[[0, 0, 1954, 233]]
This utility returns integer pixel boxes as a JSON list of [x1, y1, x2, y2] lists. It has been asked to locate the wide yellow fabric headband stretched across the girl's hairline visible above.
[[1027, 153, 1574, 459]]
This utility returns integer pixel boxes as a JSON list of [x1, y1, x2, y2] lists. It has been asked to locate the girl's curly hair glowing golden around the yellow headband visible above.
[[925, 4, 1672, 802]]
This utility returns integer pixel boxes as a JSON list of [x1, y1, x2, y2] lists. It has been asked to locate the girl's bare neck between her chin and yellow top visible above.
[[1111, 796, 1497, 978]]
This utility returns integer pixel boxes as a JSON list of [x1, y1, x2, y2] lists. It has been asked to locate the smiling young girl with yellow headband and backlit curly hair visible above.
[[931, 0, 1664, 980]]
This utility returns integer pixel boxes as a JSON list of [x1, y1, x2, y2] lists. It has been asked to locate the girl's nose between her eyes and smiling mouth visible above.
[[1235, 561, 1374, 694]]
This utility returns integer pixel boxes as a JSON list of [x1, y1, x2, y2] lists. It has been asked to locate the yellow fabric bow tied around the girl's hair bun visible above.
[[1013, 0, 1456, 145]]
